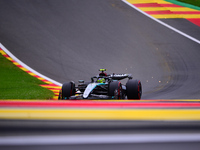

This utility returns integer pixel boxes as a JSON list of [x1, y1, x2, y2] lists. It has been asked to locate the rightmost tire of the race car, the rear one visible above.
[[126, 80, 142, 99]]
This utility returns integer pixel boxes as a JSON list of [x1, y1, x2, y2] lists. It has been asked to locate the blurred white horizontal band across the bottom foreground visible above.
[[0, 133, 200, 146]]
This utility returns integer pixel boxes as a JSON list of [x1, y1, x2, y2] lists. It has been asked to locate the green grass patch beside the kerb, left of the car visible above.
[[0, 54, 54, 99]]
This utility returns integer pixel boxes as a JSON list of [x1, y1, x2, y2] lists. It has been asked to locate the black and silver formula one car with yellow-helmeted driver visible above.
[[58, 69, 142, 100]]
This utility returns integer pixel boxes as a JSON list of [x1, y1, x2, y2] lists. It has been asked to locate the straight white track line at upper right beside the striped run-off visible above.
[[122, 0, 200, 44]]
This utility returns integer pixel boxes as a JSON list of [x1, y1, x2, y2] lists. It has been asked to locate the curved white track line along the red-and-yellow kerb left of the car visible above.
[[0, 43, 62, 86]]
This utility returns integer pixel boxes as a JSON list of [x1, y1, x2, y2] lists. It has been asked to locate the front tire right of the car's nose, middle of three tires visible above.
[[108, 81, 122, 99]]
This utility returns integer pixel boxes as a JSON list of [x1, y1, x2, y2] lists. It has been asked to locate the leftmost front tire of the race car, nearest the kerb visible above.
[[62, 81, 75, 99]]
